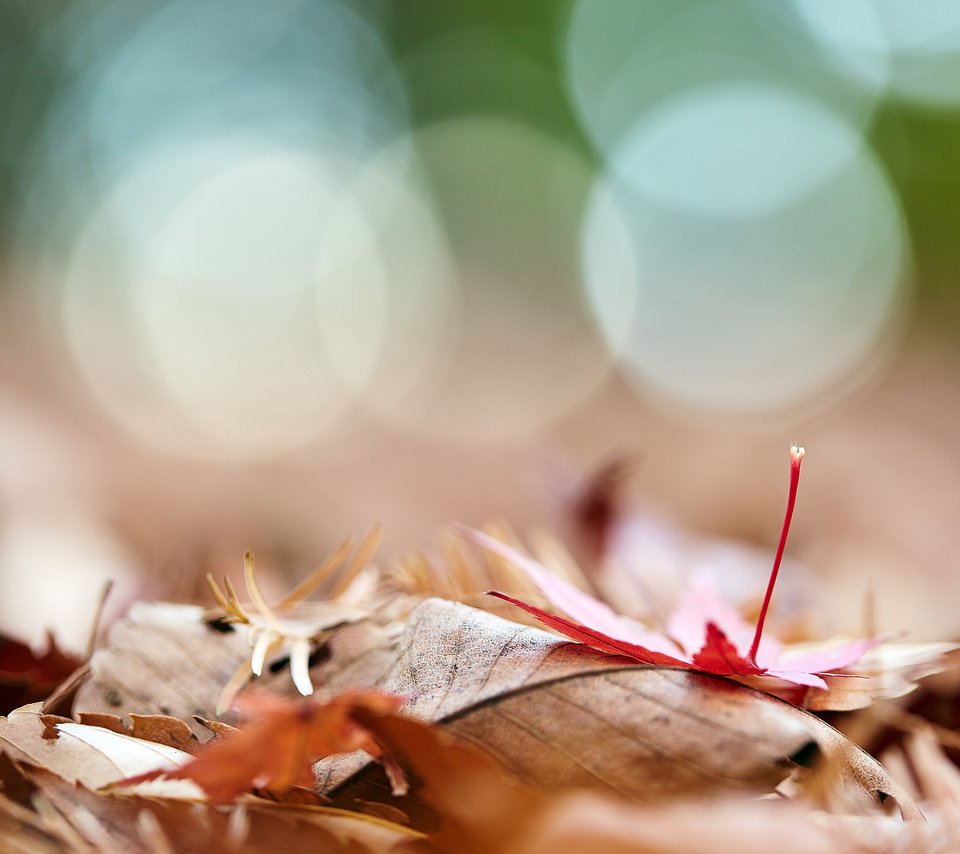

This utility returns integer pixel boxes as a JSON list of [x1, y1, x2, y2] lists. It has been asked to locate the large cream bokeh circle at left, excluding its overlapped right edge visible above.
[[63, 140, 362, 462]]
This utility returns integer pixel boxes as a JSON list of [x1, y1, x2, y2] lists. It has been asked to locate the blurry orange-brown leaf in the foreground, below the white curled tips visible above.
[[123, 692, 402, 803]]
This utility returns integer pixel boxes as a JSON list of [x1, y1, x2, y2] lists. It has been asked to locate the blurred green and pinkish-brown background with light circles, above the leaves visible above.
[[0, 0, 960, 645]]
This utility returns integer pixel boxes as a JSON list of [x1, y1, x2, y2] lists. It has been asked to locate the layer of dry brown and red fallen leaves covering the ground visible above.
[[0, 452, 960, 852]]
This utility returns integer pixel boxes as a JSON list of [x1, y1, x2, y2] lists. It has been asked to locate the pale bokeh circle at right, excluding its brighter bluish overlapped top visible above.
[[583, 92, 908, 412]]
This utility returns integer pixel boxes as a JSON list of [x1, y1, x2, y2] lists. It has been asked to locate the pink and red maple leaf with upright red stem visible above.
[[461, 446, 879, 689]]
